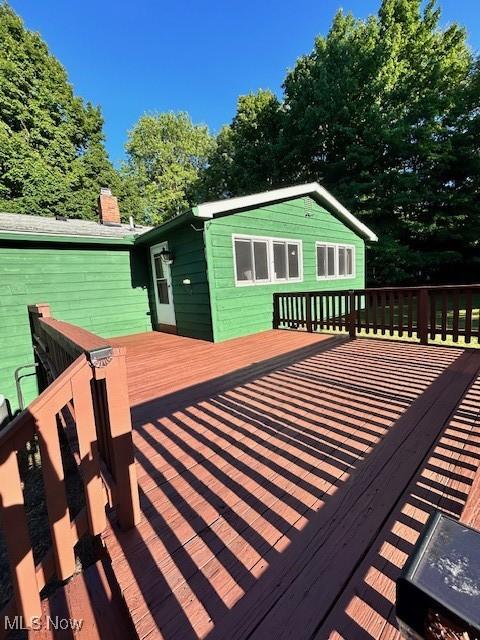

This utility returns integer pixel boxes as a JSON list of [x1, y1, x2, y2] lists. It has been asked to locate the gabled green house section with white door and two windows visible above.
[[139, 183, 377, 342]]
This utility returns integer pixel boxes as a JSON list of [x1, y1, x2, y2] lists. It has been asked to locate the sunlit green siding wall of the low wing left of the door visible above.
[[0, 243, 151, 407]]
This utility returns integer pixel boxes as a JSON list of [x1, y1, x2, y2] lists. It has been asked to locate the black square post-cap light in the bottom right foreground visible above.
[[396, 513, 480, 640]]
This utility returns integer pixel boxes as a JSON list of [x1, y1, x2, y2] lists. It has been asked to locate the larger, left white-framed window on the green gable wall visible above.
[[233, 236, 302, 286]]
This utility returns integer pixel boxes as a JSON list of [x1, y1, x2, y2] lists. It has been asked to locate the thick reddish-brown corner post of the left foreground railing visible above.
[[89, 348, 140, 529]]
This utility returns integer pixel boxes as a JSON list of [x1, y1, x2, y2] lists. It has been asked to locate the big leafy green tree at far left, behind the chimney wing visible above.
[[0, 4, 118, 218]]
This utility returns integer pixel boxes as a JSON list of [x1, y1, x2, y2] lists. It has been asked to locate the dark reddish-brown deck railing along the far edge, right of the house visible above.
[[273, 285, 480, 345]]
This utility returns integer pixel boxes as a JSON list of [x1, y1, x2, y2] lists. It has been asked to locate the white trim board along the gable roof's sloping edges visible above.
[[194, 182, 378, 242]]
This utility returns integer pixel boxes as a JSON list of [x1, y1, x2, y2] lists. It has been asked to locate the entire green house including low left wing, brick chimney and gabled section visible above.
[[0, 183, 377, 406]]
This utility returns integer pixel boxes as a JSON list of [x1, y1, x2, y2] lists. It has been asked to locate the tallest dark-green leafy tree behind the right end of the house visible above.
[[283, 0, 477, 282]]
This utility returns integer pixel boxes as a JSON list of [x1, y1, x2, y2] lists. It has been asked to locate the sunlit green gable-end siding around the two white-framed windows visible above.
[[206, 198, 365, 342]]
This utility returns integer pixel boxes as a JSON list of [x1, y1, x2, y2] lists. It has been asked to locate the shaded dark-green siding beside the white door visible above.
[[148, 222, 212, 340]]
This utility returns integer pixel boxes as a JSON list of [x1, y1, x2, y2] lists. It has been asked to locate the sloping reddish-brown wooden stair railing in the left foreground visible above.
[[0, 305, 140, 636]]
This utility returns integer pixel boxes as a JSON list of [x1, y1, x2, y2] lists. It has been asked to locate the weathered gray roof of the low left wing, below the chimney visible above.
[[0, 212, 151, 238]]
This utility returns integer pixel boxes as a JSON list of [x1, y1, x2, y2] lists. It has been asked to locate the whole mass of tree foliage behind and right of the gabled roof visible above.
[[200, 0, 480, 283]]
